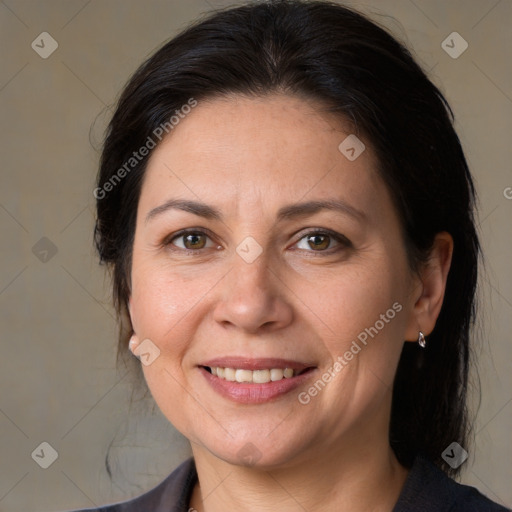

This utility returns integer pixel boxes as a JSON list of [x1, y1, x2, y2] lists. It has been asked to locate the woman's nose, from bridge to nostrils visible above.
[[213, 249, 293, 334]]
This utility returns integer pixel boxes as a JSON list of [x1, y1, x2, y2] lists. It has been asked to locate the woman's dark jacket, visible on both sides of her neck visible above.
[[71, 457, 510, 512]]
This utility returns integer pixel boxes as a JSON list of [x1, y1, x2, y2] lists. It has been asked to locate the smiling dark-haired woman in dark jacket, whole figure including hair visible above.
[[78, 1, 505, 512]]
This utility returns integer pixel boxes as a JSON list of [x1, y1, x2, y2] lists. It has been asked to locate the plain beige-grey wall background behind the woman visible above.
[[0, 0, 512, 512]]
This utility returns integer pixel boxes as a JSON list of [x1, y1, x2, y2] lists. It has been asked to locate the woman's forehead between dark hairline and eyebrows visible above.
[[141, 95, 386, 220]]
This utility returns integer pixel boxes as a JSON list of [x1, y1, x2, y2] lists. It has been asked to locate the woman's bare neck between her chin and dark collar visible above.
[[190, 436, 408, 512]]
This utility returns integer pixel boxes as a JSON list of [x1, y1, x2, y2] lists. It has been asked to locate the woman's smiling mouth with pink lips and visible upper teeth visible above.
[[199, 357, 316, 404]]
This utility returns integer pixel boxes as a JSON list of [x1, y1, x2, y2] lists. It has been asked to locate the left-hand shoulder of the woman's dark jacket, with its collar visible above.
[[65, 458, 197, 512]]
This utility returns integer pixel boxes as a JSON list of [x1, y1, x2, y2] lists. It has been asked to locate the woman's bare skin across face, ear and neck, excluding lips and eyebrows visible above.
[[129, 94, 453, 512]]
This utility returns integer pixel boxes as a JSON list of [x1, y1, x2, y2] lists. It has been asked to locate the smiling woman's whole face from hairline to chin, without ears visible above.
[[130, 95, 418, 467]]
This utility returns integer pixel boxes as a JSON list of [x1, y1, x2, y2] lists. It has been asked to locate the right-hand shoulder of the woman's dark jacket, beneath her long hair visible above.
[[393, 457, 510, 512]]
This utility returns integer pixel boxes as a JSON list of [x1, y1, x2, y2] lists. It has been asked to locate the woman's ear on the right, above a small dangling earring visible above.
[[405, 231, 453, 341]]
